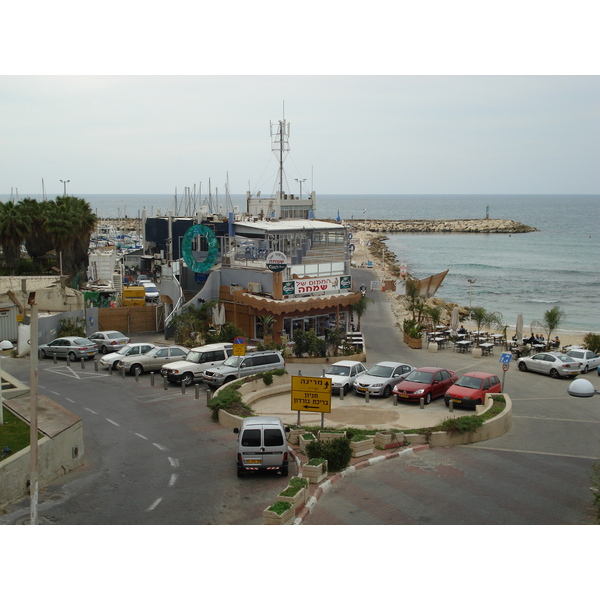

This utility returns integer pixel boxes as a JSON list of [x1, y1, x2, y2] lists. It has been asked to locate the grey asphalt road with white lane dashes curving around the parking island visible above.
[[0, 269, 600, 525]]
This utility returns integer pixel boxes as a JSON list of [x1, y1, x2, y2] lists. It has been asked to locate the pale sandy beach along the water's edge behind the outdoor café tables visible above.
[[353, 230, 583, 348]]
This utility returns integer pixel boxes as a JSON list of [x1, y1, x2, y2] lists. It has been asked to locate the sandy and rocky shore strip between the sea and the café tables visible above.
[[353, 230, 588, 348]]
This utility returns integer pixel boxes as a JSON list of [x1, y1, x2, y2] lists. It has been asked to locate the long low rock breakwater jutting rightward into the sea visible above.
[[347, 219, 538, 233]]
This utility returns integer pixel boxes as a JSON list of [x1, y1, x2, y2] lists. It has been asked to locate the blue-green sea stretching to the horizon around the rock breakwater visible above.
[[0, 194, 600, 335]]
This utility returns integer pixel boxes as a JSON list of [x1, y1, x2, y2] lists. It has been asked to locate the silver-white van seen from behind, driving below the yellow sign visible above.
[[233, 417, 290, 477]]
